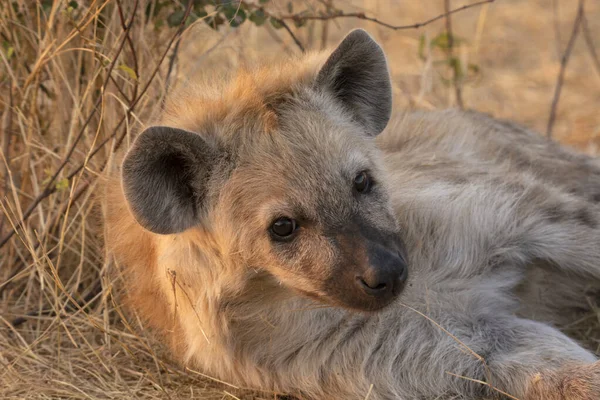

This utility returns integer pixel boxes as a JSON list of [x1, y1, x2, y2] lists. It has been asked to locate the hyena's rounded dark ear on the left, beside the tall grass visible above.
[[122, 126, 216, 234]]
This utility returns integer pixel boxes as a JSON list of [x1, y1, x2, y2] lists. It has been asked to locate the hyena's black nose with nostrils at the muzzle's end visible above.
[[356, 252, 408, 297]]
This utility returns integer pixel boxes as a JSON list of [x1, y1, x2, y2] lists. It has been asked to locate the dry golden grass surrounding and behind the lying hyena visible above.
[[0, 0, 600, 399]]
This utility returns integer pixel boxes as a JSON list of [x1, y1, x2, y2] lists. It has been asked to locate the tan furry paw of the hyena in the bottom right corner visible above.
[[524, 361, 600, 400]]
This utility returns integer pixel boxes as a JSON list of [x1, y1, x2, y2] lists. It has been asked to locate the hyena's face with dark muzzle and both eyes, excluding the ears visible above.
[[221, 112, 407, 311]]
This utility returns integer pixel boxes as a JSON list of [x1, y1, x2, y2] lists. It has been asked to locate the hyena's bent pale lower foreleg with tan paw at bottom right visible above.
[[466, 318, 600, 400]]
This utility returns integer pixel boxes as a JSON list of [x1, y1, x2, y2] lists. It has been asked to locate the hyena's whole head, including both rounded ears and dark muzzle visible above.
[[123, 30, 407, 311]]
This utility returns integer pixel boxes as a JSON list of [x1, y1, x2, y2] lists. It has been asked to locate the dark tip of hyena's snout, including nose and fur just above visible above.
[[354, 242, 408, 301]]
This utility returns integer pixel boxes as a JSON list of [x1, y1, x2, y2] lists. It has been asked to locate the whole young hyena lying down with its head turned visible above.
[[106, 30, 600, 400]]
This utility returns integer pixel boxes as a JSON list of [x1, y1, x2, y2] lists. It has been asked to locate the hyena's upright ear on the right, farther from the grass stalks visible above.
[[316, 29, 392, 135]]
